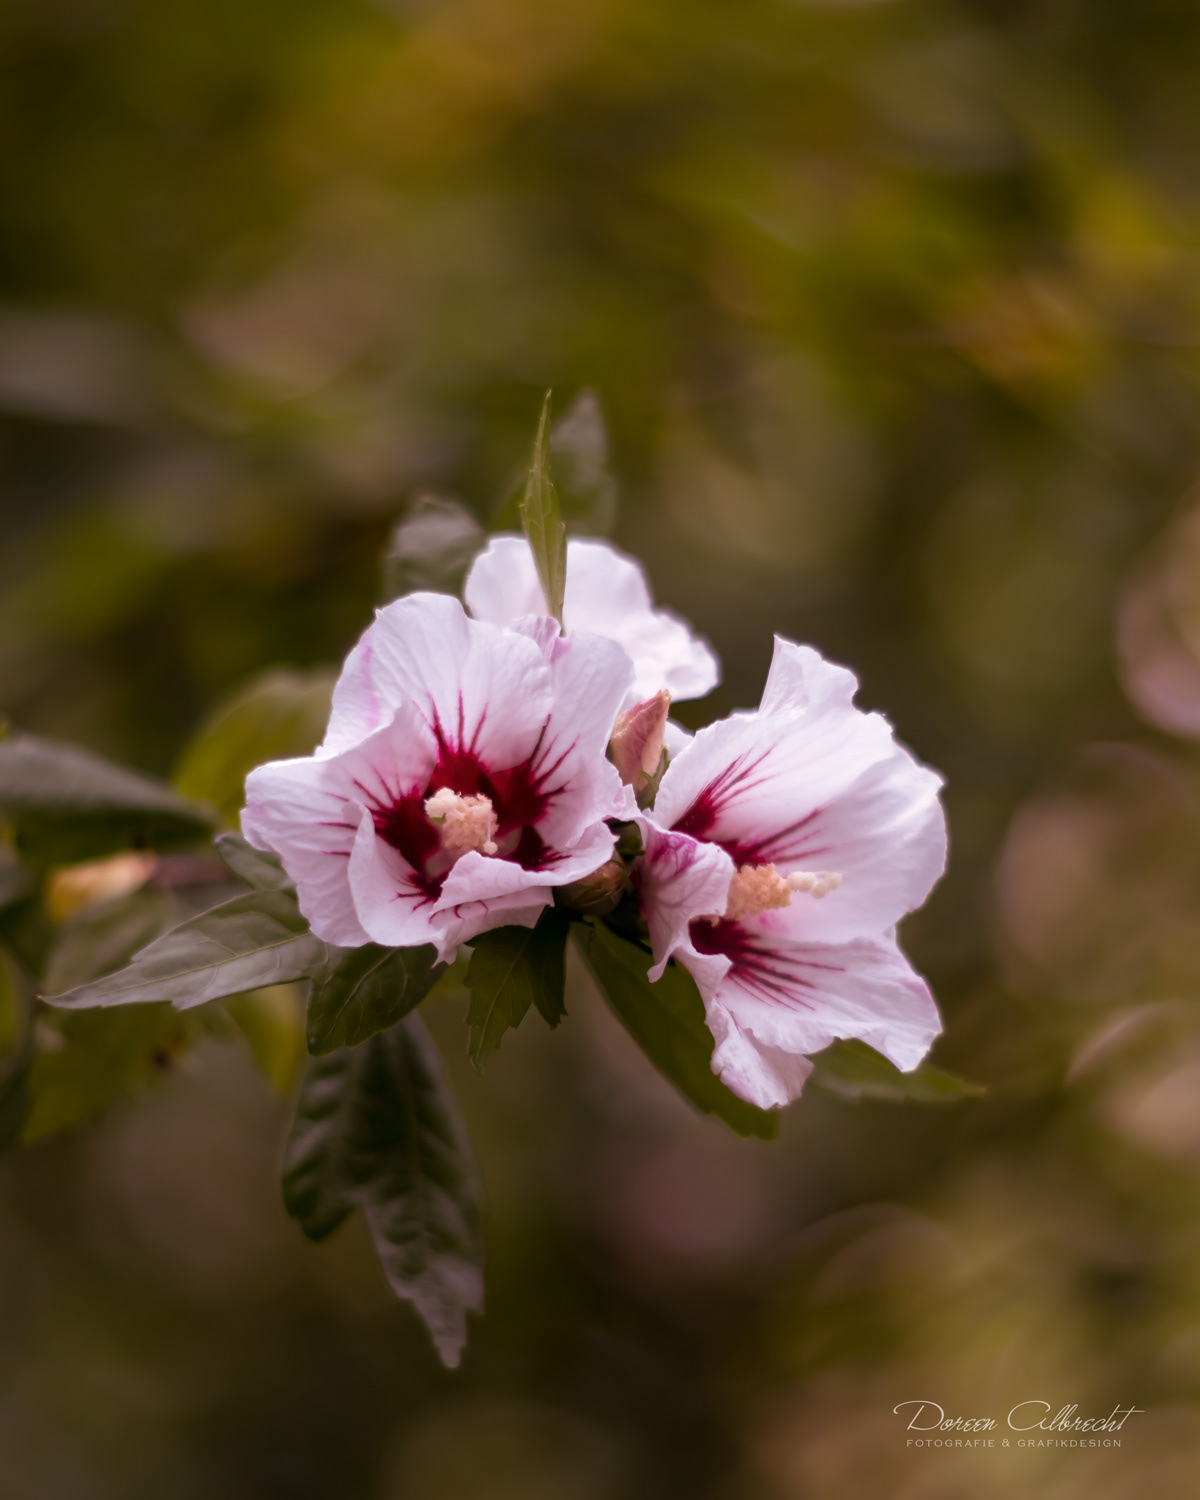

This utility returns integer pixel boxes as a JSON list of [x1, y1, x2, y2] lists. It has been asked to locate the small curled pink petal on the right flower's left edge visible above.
[[636, 815, 734, 998]]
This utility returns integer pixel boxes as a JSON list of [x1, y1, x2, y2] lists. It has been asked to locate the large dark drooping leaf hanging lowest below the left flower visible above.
[[284, 1016, 483, 1367]]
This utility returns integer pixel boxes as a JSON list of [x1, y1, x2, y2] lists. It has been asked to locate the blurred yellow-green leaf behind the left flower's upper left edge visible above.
[[174, 672, 335, 828]]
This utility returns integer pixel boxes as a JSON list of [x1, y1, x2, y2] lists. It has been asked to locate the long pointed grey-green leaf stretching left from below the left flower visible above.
[[47, 891, 326, 1011]]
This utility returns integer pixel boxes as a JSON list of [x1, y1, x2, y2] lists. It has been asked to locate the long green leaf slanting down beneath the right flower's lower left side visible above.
[[578, 923, 779, 1140]]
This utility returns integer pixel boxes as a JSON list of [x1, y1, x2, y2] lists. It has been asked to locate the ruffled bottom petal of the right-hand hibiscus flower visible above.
[[693, 924, 942, 1109]]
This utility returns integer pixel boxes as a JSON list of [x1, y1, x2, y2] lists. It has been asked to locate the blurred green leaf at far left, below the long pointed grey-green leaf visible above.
[[21, 1005, 191, 1142]]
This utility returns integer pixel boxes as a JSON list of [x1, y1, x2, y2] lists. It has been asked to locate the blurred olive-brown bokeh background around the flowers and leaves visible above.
[[0, 0, 1200, 1500]]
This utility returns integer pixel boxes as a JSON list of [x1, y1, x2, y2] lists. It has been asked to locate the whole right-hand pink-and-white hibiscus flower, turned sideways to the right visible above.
[[638, 638, 947, 1109]]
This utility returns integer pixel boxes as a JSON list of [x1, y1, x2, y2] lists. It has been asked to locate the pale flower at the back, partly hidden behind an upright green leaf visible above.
[[464, 537, 722, 704]]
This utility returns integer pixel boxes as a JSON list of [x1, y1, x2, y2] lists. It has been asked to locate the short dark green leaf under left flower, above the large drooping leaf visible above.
[[308, 944, 446, 1056]]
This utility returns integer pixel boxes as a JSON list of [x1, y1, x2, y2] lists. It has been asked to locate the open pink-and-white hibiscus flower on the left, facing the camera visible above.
[[242, 594, 632, 962]]
